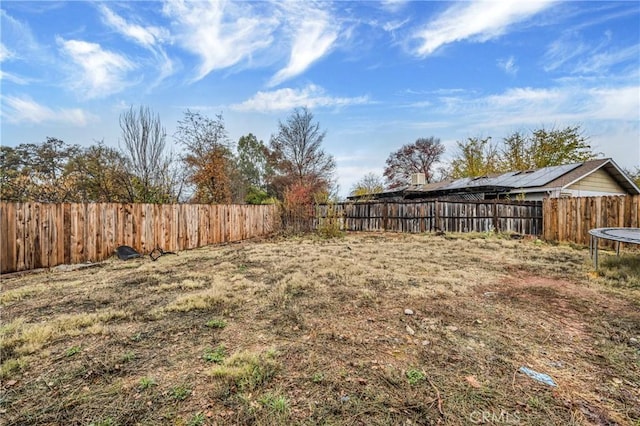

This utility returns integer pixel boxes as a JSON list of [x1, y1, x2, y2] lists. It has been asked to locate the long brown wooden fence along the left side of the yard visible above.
[[0, 202, 279, 273]]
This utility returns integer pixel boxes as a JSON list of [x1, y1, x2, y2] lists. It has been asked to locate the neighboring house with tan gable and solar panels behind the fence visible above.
[[349, 158, 640, 200]]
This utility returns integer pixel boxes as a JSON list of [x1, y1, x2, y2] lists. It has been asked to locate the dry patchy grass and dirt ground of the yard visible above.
[[0, 234, 640, 425]]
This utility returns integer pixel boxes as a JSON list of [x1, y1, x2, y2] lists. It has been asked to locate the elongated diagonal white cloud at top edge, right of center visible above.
[[414, 0, 552, 57]]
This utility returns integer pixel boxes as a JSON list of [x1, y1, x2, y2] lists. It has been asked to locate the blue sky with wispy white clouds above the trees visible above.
[[0, 0, 640, 196]]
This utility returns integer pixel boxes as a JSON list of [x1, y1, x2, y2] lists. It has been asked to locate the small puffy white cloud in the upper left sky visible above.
[[56, 37, 135, 98]]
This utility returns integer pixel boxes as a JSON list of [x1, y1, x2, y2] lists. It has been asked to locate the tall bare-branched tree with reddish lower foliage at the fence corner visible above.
[[268, 108, 336, 197]]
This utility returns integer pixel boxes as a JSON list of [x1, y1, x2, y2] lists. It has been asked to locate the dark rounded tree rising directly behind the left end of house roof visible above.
[[384, 136, 444, 188]]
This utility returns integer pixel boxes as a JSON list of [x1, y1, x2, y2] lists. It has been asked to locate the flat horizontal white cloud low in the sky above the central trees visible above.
[[231, 84, 370, 112]]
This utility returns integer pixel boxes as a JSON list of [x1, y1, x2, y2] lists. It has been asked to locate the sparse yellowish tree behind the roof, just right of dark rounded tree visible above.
[[450, 137, 500, 179]]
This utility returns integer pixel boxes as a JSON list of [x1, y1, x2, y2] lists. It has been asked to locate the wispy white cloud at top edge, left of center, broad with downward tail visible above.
[[163, 0, 278, 81]]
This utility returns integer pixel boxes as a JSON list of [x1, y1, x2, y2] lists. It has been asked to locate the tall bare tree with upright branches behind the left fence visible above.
[[120, 106, 179, 203]]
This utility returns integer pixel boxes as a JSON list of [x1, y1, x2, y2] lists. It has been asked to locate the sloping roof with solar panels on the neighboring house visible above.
[[352, 158, 640, 198]]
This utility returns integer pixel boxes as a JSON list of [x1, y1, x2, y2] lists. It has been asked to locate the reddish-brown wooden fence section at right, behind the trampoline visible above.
[[543, 195, 640, 245]]
